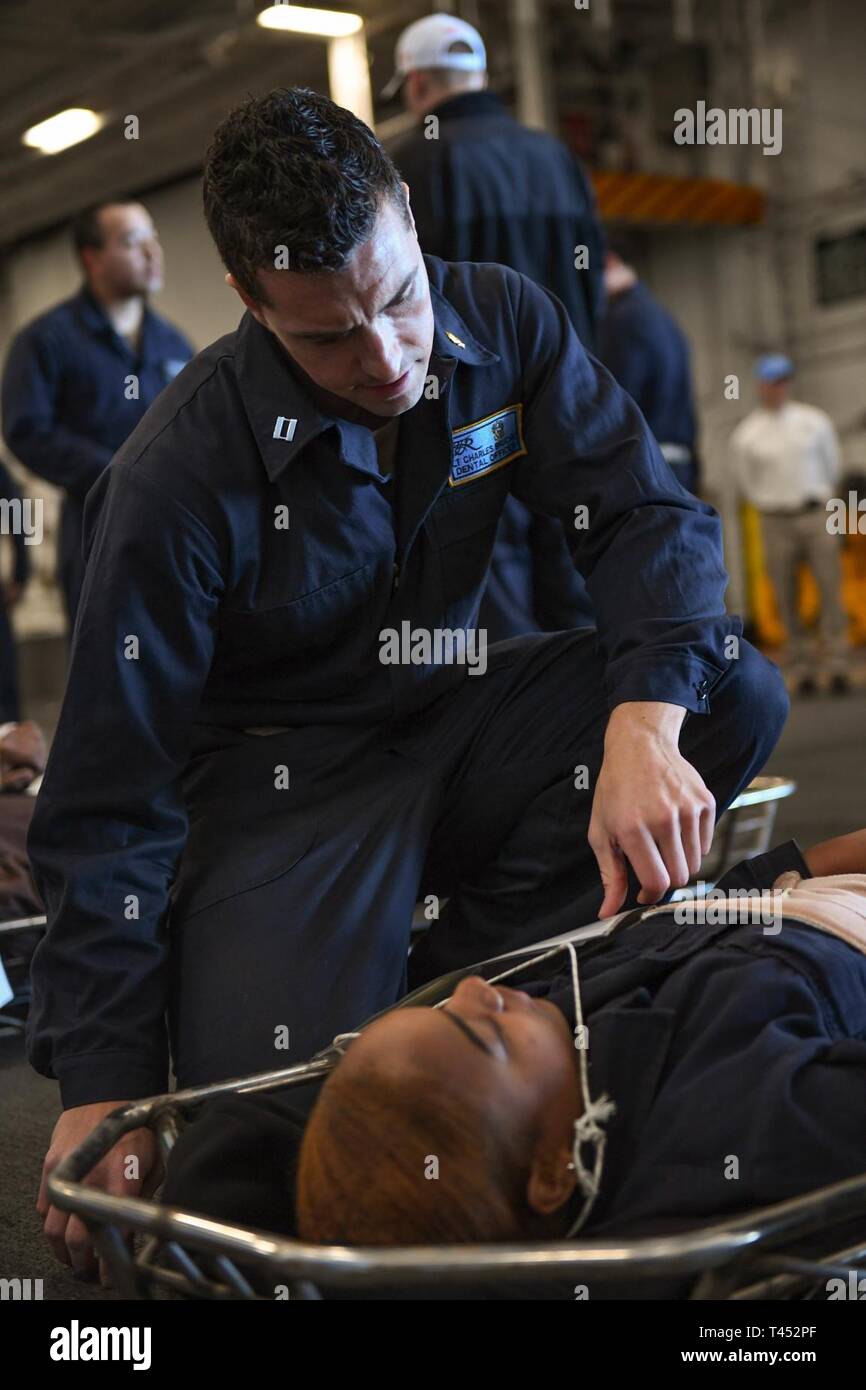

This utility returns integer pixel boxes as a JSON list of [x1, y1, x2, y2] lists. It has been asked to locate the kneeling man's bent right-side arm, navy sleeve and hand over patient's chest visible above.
[[513, 271, 742, 915]]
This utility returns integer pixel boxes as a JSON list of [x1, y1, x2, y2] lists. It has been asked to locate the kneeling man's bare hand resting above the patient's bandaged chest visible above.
[[588, 701, 716, 917]]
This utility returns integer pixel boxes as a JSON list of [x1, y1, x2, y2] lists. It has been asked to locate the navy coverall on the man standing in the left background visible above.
[[3, 285, 193, 627]]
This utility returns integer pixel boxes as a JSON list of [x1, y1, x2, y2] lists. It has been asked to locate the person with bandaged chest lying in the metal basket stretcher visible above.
[[163, 830, 866, 1289]]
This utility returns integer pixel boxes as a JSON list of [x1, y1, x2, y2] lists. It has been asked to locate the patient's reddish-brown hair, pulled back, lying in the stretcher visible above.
[[296, 1062, 538, 1245]]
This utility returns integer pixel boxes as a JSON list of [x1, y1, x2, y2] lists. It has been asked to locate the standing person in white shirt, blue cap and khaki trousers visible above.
[[731, 353, 849, 695]]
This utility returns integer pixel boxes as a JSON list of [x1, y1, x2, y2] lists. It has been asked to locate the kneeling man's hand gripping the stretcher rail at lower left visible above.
[[36, 1101, 163, 1283]]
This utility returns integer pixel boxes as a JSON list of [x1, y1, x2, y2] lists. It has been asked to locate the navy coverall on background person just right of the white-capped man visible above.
[[598, 282, 698, 492]]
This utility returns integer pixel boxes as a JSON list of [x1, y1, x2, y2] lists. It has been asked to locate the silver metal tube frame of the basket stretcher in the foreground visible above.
[[47, 913, 866, 1301]]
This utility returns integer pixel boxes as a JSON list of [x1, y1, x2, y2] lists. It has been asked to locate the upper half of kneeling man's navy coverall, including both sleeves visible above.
[[29, 257, 741, 1105]]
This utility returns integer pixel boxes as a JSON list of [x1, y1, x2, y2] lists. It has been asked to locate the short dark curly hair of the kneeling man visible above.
[[203, 88, 405, 304]]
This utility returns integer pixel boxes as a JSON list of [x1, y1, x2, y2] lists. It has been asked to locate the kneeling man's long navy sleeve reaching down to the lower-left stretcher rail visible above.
[[28, 464, 221, 1108]]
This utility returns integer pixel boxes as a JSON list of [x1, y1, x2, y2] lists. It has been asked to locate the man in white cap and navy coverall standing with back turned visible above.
[[382, 14, 605, 642]]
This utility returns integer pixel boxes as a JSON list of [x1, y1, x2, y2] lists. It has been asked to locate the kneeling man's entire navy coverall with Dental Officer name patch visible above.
[[28, 257, 787, 1106]]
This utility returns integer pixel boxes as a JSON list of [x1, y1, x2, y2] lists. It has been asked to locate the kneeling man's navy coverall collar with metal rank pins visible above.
[[235, 273, 500, 482]]
